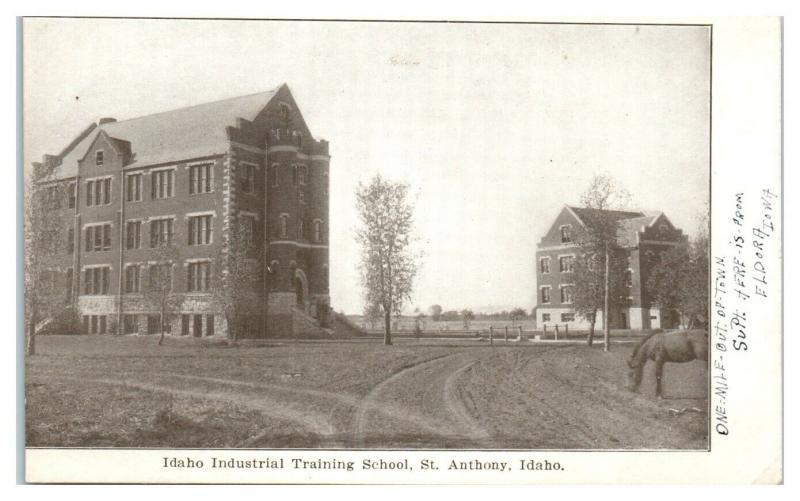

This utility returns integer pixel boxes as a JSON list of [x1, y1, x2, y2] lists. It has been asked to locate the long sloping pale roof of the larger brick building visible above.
[[43, 84, 286, 181]]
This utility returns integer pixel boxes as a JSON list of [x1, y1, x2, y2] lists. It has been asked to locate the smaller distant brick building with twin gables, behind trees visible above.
[[536, 206, 686, 329]]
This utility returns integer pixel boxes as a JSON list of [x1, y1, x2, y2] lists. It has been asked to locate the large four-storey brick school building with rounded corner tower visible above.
[[34, 84, 330, 336]]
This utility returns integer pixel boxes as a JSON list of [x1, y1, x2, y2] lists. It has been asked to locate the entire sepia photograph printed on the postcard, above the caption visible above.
[[22, 18, 712, 454]]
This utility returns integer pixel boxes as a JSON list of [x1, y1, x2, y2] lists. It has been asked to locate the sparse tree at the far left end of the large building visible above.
[[23, 173, 67, 355]]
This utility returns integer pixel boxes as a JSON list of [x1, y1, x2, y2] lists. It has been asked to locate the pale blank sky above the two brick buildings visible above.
[[23, 19, 710, 313]]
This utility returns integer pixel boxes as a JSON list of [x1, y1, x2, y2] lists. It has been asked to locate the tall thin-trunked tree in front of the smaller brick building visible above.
[[576, 174, 631, 351]]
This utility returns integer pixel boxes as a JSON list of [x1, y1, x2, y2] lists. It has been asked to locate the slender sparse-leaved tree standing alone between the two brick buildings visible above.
[[356, 175, 419, 345]]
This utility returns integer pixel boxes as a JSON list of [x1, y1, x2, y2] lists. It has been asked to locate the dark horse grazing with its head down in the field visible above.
[[628, 330, 708, 398]]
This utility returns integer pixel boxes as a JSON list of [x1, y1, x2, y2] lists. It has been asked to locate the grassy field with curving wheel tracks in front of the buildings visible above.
[[26, 336, 708, 449]]
